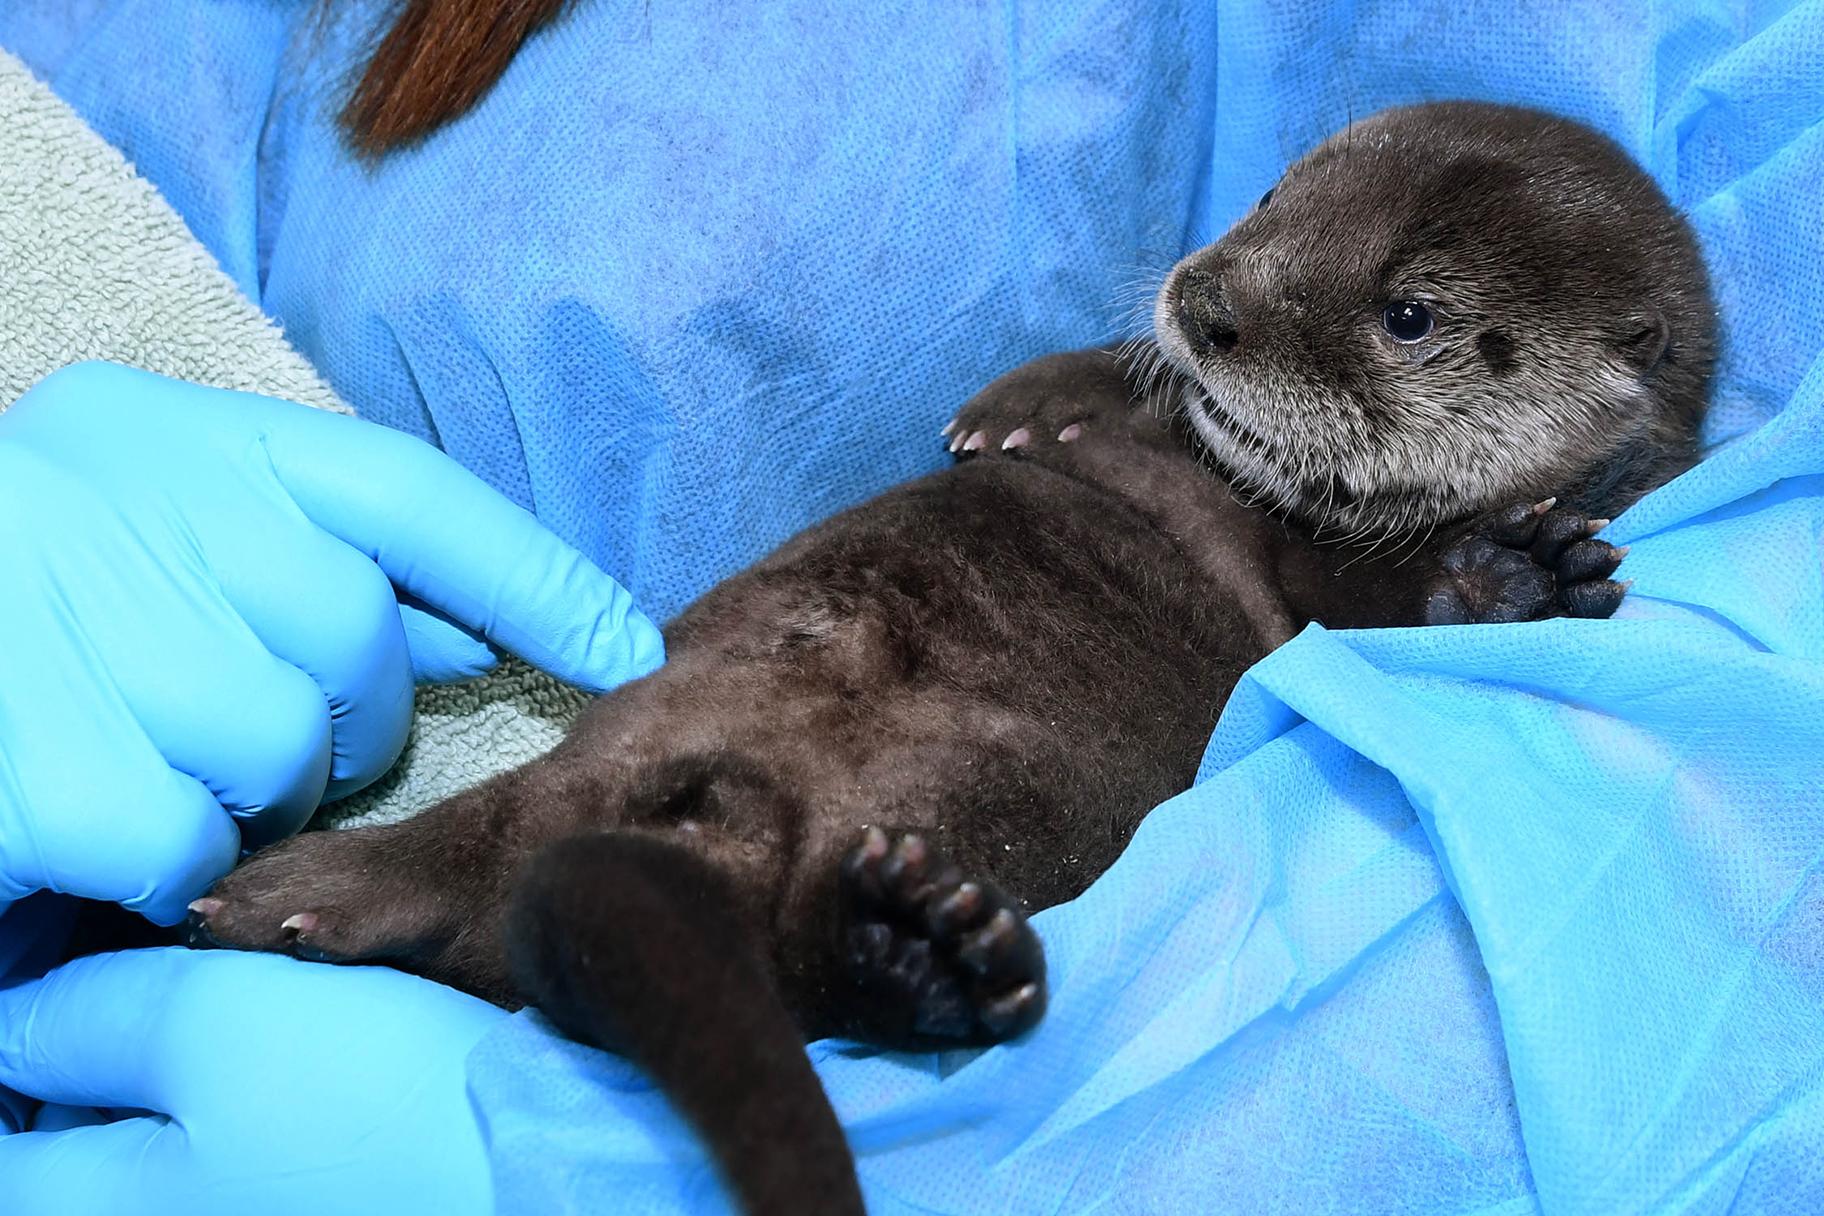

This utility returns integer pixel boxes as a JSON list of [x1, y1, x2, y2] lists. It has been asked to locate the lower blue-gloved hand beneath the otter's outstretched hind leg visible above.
[[0, 948, 507, 1216]]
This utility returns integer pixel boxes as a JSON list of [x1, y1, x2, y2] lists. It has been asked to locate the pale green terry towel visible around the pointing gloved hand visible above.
[[0, 51, 584, 822]]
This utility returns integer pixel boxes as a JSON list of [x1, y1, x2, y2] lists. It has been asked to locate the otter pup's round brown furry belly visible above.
[[651, 453, 1264, 893]]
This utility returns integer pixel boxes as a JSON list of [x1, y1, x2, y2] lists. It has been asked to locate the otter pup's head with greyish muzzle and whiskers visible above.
[[1153, 102, 1715, 536]]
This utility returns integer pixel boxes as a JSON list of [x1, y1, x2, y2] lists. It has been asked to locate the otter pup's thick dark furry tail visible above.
[[507, 835, 863, 1216]]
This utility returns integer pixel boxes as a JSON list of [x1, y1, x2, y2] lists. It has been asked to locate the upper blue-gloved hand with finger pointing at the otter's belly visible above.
[[0, 363, 664, 922]]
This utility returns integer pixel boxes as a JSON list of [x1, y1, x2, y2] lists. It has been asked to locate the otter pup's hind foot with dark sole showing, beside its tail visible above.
[[841, 828, 1045, 1046]]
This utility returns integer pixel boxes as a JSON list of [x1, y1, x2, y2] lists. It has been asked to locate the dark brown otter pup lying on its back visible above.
[[190, 104, 1715, 1212]]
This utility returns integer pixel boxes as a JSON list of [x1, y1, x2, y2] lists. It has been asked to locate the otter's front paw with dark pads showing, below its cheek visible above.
[[1425, 498, 1627, 625]]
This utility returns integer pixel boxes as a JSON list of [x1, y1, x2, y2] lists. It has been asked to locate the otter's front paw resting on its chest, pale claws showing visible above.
[[943, 350, 1167, 459]]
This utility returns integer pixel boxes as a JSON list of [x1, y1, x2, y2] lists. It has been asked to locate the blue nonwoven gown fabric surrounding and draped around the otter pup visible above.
[[0, 0, 1824, 1214]]
